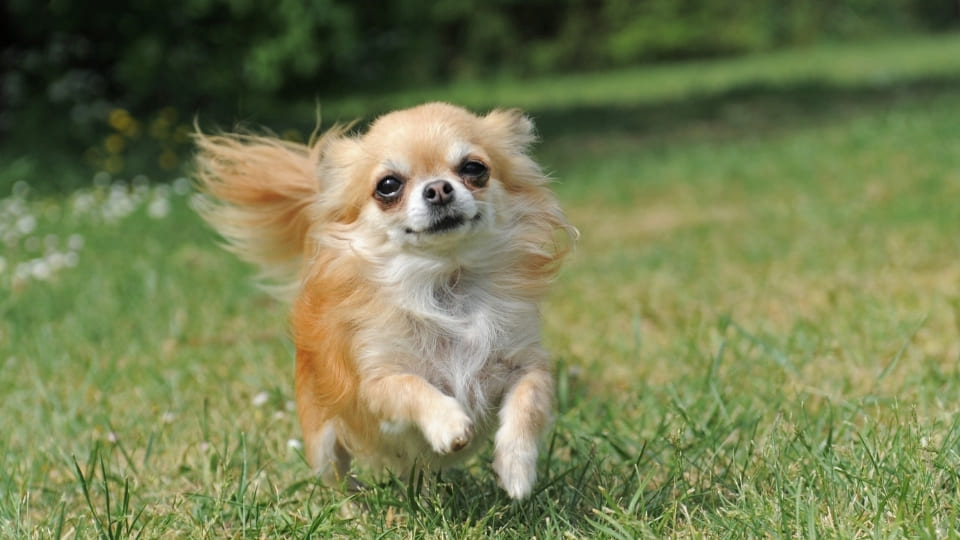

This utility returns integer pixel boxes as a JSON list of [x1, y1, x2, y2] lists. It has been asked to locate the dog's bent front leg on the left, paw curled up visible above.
[[360, 374, 473, 455]]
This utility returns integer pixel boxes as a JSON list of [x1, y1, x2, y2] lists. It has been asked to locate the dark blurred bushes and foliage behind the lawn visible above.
[[0, 0, 960, 192]]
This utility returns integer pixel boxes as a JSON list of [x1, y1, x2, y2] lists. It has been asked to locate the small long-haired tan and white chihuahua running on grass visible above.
[[196, 103, 577, 499]]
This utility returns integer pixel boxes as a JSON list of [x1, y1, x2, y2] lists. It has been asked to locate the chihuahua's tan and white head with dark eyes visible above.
[[316, 104, 539, 250]]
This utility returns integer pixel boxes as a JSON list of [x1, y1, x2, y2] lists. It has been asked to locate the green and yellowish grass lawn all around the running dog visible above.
[[0, 36, 960, 538]]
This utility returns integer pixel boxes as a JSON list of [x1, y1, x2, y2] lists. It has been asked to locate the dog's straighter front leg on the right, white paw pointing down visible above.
[[493, 368, 553, 499]]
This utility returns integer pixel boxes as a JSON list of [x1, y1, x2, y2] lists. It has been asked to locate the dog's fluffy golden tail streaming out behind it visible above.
[[195, 128, 343, 299]]
